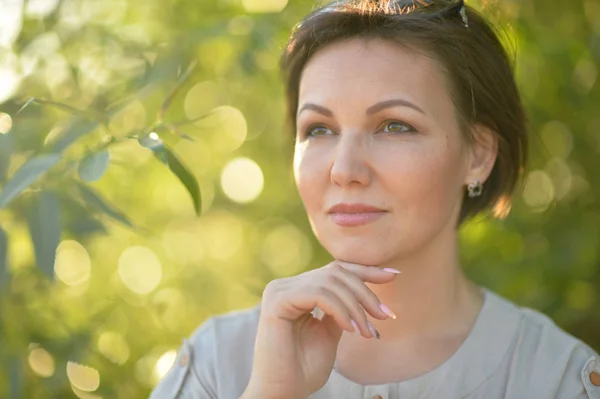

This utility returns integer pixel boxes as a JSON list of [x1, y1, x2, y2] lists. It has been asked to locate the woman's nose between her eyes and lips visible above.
[[331, 134, 371, 187]]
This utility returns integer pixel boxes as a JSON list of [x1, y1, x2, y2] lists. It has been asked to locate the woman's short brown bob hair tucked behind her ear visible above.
[[281, 0, 528, 224]]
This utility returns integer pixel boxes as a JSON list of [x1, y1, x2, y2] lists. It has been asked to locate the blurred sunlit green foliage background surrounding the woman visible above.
[[0, 0, 600, 398]]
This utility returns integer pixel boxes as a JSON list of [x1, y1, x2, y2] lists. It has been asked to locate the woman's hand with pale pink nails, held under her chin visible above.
[[241, 261, 399, 399]]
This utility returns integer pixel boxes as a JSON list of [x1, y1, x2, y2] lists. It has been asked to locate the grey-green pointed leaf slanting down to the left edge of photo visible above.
[[0, 154, 60, 208]]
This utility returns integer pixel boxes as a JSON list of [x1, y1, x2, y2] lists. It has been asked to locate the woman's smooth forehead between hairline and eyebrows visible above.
[[299, 38, 450, 108]]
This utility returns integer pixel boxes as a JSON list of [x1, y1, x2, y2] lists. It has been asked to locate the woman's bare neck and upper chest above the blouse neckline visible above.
[[367, 225, 483, 341]]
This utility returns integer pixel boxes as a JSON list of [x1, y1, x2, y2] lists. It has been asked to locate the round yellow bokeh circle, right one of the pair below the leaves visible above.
[[119, 246, 162, 295]]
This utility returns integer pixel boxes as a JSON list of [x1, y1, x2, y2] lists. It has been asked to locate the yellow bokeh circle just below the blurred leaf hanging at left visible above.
[[54, 240, 92, 287]]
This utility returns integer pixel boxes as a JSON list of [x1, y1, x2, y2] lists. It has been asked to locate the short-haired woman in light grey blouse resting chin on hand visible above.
[[153, 0, 600, 399]]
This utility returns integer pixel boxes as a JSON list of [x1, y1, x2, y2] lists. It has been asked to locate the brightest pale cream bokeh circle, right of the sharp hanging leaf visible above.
[[221, 158, 264, 203]]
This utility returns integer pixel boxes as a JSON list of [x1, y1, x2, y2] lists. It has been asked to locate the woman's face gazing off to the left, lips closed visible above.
[[294, 39, 482, 265]]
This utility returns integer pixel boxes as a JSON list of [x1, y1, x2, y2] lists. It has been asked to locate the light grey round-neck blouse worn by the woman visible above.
[[151, 287, 600, 399]]
